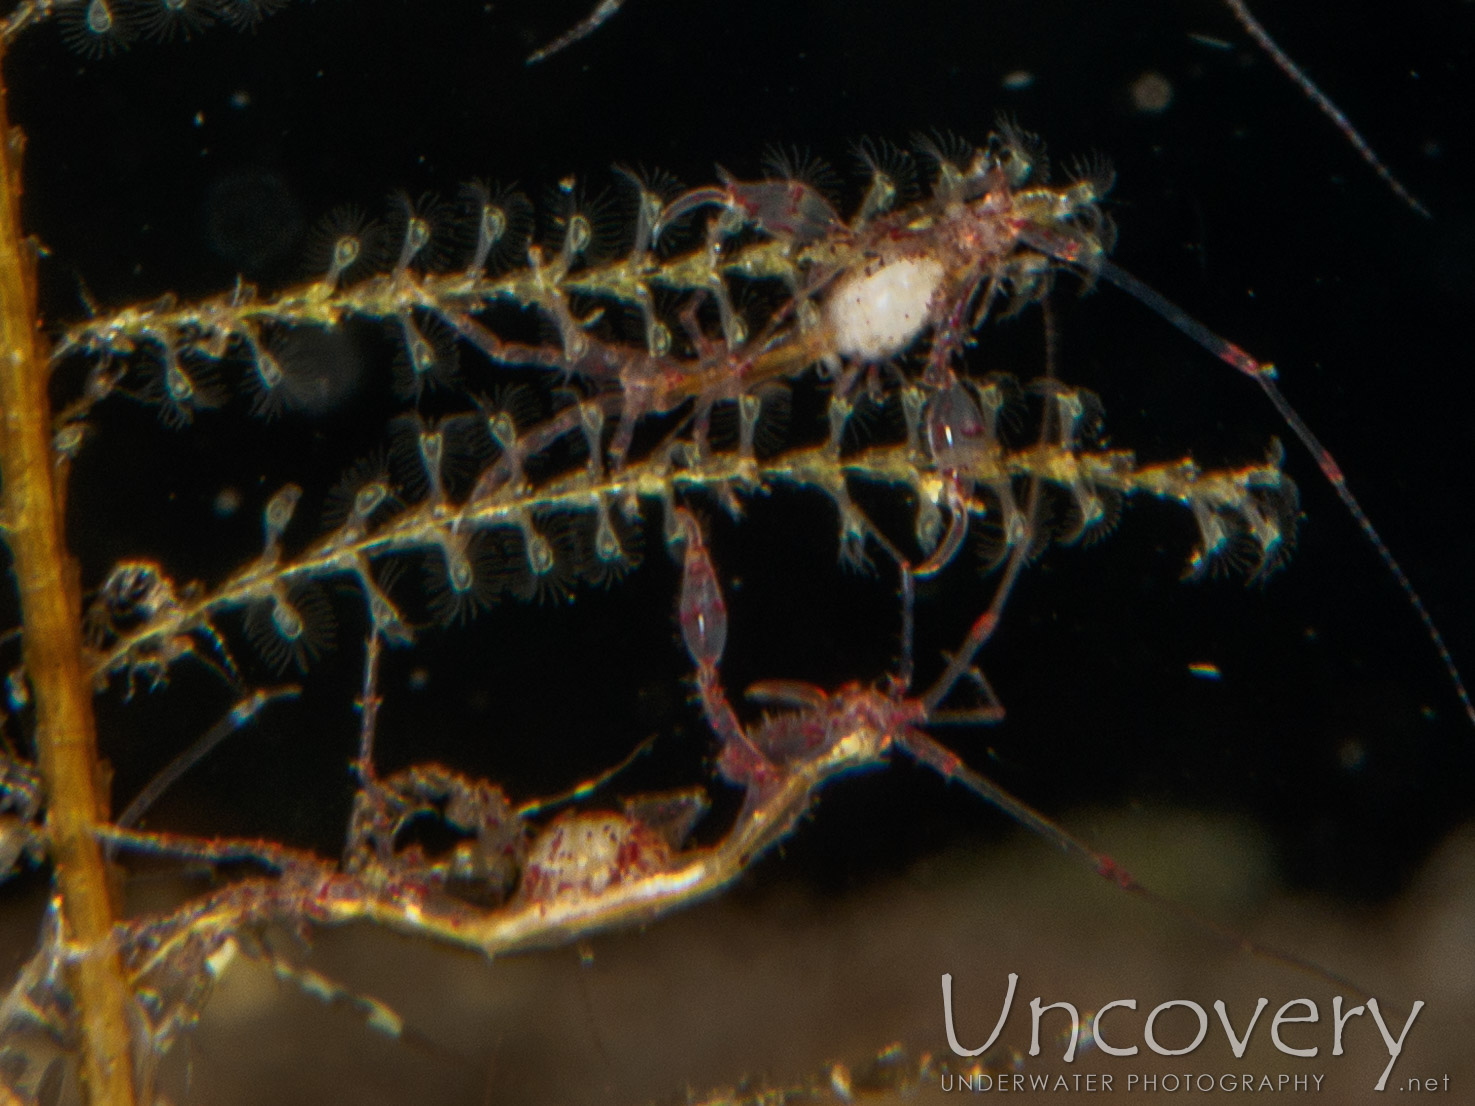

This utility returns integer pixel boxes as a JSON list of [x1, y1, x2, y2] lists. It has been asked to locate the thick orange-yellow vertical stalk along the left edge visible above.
[[0, 43, 133, 1106]]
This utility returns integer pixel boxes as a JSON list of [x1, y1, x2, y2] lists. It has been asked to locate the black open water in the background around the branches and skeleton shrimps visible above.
[[7, 0, 1475, 1103]]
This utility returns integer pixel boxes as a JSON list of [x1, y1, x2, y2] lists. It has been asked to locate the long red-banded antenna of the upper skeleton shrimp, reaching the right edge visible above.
[[1092, 258, 1475, 724]]
